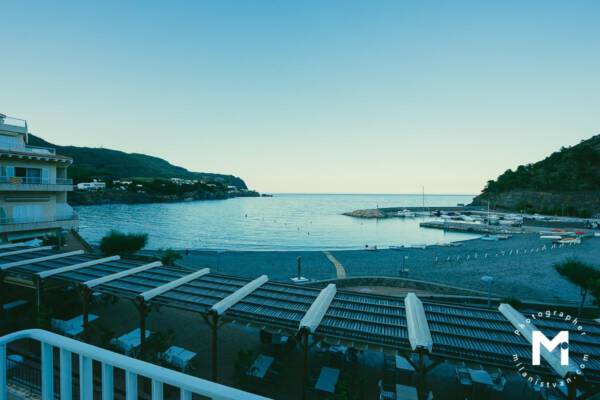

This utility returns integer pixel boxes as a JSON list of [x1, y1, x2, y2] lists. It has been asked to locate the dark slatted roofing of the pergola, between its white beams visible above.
[[0, 248, 600, 383]]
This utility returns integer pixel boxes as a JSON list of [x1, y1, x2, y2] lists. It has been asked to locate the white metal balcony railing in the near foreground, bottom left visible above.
[[0, 329, 268, 400]]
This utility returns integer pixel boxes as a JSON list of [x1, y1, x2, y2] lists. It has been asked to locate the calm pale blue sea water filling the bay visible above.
[[77, 194, 474, 250]]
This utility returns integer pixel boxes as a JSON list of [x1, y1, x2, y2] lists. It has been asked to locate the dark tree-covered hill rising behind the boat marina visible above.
[[473, 135, 600, 216]]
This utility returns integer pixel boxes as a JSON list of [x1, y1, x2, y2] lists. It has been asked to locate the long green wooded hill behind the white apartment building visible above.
[[29, 134, 247, 189]]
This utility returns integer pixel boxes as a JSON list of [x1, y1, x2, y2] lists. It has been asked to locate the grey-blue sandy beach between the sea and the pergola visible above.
[[180, 233, 600, 303]]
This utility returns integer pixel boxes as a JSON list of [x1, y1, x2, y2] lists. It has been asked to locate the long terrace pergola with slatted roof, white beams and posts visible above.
[[0, 246, 600, 399]]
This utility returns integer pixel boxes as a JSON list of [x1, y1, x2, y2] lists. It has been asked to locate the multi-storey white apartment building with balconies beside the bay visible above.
[[0, 114, 78, 242]]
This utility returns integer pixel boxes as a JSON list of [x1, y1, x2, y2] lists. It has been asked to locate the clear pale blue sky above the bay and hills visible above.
[[0, 1, 600, 193]]
